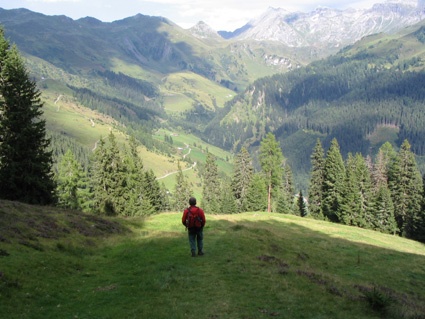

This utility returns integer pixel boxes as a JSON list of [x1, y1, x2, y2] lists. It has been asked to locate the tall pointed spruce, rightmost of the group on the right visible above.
[[389, 140, 423, 238]]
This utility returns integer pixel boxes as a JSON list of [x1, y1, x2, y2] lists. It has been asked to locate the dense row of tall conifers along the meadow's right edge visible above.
[[308, 139, 425, 242]]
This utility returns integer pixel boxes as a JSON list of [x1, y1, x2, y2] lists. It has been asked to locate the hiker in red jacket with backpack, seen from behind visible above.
[[182, 197, 206, 257]]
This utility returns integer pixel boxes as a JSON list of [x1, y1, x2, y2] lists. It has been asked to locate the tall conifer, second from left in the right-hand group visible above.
[[322, 139, 345, 222]]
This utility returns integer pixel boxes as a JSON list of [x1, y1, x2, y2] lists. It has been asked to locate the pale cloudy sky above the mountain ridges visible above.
[[0, 0, 384, 31]]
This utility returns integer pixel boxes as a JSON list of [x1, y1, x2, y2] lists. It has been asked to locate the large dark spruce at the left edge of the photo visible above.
[[0, 29, 56, 205]]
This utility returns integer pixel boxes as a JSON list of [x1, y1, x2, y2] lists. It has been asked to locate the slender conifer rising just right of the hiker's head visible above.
[[202, 152, 221, 214]]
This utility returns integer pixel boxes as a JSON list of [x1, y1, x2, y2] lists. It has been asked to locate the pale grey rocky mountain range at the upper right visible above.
[[218, 0, 425, 49]]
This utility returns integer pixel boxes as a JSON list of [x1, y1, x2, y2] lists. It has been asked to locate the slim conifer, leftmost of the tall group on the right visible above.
[[308, 139, 325, 219]]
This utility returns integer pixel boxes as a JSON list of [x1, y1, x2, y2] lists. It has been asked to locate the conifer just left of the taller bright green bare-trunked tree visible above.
[[231, 147, 254, 210]]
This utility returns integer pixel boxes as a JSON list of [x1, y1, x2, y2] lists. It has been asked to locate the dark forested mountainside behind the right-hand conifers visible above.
[[205, 21, 425, 182]]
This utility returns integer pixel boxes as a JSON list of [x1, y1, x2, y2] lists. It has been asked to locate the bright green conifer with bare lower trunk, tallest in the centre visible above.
[[259, 133, 283, 213]]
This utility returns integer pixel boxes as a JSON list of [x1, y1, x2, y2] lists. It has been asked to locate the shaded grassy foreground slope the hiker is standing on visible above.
[[0, 201, 425, 319]]
